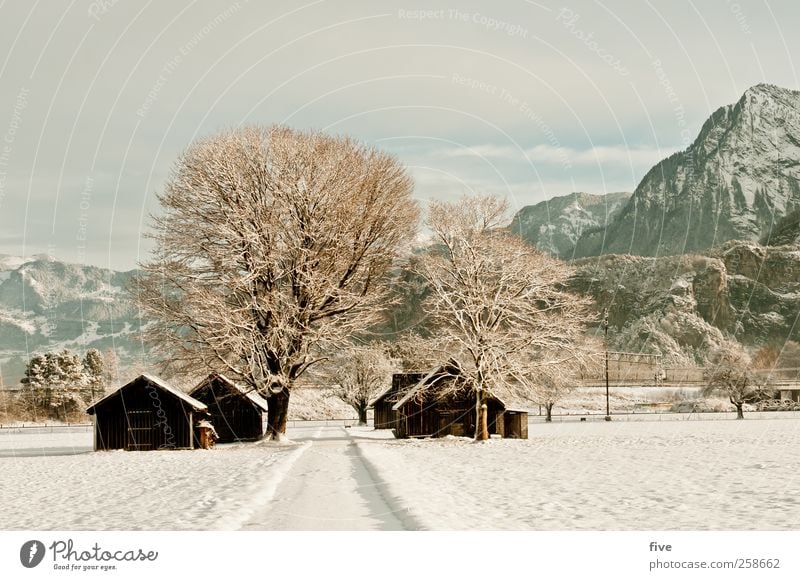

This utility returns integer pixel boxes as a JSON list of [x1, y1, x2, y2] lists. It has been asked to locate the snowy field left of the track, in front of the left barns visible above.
[[0, 429, 304, 530]]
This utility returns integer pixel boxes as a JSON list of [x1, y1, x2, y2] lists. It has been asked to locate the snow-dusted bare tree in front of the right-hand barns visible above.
[[419, 196, 589, 440]]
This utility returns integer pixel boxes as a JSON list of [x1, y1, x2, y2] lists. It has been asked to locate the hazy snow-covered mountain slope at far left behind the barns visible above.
[[0, 255, 141, 385]]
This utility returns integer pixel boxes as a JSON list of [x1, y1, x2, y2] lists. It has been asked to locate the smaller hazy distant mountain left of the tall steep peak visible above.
[[510, 193, 631, 257]]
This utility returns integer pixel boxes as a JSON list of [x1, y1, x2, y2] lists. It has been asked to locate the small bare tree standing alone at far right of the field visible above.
[[703, 341, 764, 419]]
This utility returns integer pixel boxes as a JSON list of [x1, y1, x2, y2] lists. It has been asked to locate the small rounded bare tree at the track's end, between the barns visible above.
[[330, 343, 397, 425]]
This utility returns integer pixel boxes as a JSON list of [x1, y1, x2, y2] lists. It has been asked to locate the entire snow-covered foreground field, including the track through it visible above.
[[0, 417, 800, 530]]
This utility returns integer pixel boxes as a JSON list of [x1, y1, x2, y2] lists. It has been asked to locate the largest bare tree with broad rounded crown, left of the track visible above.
[[135, 126, 418, 439]]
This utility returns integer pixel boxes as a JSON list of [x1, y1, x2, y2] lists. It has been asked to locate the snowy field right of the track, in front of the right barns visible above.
[[360, 419, 800, 530]]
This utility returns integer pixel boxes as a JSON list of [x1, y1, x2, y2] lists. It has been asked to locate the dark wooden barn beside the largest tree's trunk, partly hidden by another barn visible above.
[[189, 373, 267, 443]]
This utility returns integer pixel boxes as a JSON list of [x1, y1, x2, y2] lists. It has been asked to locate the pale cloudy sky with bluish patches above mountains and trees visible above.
[[0, 0, 800, 270]]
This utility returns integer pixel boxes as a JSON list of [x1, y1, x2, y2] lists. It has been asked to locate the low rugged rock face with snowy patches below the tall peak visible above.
[[571, 241, 800, 364]]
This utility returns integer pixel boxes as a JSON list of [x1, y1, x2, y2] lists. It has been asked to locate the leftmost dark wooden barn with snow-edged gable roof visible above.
[[86, 375, 208, 451]]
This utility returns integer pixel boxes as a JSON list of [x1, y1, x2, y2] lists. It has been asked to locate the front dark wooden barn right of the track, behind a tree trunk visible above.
[[392, 360, 505, 438]]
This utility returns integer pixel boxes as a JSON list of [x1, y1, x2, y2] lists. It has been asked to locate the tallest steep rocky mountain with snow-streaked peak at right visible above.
[[575, 84, 800, 256]]
